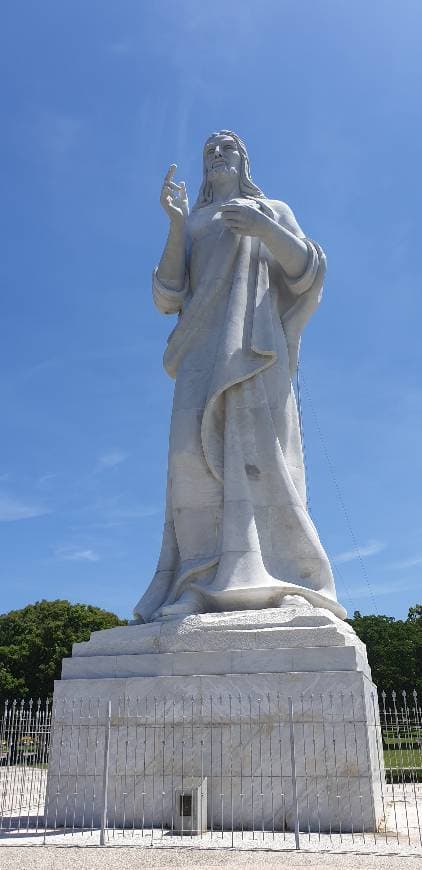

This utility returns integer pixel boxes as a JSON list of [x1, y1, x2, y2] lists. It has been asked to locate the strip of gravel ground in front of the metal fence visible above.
[[0, 846, 421, 870]]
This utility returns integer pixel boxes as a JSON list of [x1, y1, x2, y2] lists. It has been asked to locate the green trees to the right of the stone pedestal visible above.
[[349, 604, 422, 697]]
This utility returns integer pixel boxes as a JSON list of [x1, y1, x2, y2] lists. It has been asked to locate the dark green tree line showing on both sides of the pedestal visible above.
[[0, 600, 422, 703]]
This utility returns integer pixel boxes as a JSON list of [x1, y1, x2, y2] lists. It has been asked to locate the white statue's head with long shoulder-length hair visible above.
[[194, 130, 264, 208]]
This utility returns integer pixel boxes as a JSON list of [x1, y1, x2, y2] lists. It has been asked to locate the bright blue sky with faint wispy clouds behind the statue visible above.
[[0, 0, 422, 617]]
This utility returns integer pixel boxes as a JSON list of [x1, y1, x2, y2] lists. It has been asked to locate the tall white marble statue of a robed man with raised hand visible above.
[[135, 130, 345, 622]]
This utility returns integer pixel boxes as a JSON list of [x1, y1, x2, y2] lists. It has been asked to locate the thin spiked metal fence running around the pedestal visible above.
[[0, 692, 422, 849]]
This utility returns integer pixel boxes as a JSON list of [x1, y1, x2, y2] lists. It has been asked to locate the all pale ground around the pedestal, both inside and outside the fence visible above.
[[0, 768, 422, 870]]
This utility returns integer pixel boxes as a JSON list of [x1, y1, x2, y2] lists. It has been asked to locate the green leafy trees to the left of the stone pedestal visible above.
[[0, 600, 126, 702]]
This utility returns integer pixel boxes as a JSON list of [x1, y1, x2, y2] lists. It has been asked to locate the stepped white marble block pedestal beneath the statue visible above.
[[47, 605, 383, 832]]
